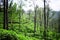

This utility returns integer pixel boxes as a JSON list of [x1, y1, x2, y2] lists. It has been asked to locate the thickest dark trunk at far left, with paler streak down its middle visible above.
[[3, 0, 8, 30]]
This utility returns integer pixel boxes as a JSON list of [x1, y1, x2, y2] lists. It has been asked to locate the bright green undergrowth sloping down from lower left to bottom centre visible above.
[[0, 29, 38, 40]]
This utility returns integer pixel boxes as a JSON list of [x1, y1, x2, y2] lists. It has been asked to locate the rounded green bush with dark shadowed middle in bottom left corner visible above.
[[0, 29, 18, 40]]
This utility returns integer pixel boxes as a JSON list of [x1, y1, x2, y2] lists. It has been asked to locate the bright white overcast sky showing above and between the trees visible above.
[[14, 0, 60, 11]]
